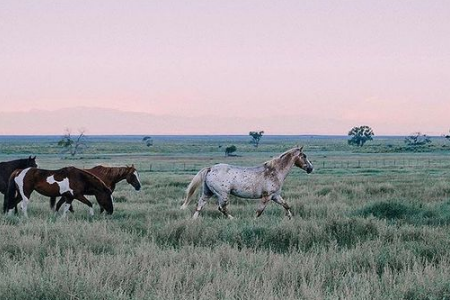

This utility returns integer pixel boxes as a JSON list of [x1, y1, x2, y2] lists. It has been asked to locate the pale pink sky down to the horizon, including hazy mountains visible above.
[[0, 0, 450, 135]]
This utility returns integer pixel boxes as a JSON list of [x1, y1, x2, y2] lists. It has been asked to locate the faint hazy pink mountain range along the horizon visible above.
[[0, 107, 450, 135]]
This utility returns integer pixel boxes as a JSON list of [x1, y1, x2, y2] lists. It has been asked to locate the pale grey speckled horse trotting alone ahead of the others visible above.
[[181, 147, 313, 219]]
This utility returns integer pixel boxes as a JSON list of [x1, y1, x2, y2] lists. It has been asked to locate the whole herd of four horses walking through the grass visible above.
[[0, 147, 313, 219]]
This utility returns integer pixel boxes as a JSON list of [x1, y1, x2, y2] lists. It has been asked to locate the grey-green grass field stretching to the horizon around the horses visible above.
[[0, 136, 450, 300]]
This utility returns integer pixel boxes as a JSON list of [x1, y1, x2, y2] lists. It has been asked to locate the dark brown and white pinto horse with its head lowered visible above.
[[3, 167, 114, 217]]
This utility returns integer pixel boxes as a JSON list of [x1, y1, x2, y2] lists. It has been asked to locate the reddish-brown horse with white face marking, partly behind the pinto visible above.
[[50, 165, 141, 212]]
